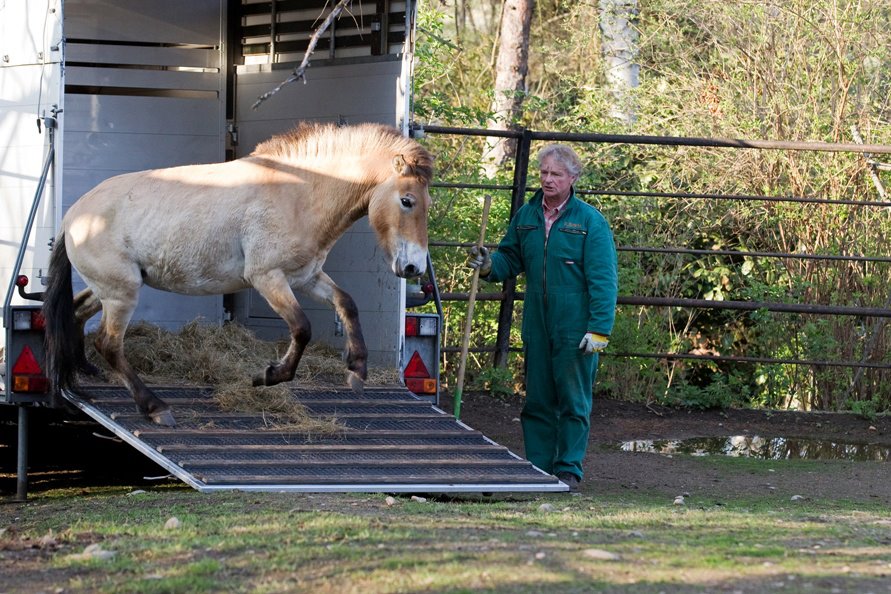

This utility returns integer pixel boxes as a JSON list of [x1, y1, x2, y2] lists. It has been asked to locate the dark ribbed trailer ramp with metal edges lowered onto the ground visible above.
[[65, 386, 568, 493]]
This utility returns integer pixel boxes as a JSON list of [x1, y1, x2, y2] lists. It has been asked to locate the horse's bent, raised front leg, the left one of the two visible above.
[[252, 271, 312, 386]]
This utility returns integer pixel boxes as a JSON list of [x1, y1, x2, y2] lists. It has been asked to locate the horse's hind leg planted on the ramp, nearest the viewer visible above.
[[96, 298, 176, 427]]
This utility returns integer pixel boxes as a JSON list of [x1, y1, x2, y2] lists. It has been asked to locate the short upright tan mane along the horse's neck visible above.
[[251, 122, 433, 184]]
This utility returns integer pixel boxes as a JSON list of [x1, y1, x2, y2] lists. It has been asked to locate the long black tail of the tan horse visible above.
[[43, 233, 83, 393]]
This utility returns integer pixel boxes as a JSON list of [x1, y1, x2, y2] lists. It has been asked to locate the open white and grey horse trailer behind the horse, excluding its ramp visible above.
[[0, 0, 536, 492]]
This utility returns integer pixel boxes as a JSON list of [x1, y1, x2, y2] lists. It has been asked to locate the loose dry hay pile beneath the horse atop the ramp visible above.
[[86, 322, 399, 434]]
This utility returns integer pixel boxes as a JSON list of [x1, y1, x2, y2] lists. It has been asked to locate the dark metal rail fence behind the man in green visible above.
[[413, 126, 891, 373]]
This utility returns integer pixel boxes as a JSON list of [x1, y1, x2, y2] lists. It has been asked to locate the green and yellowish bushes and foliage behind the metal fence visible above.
[[415, 0, 891, 412]]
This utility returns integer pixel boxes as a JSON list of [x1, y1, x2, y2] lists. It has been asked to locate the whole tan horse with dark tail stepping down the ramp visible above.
[[43, 123, 433, 426]]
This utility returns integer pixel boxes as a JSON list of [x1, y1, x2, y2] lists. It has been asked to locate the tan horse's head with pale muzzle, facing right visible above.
[[368, 149, 433, 278]]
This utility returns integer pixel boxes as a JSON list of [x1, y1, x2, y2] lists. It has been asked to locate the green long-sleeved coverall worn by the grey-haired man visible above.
[[485, 189, 618, 479]]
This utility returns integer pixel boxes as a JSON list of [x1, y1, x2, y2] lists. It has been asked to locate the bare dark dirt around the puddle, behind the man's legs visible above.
[[440, 394, 891, 505]]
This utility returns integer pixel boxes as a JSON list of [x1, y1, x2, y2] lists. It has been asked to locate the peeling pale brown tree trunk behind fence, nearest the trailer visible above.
[[483, 0, 535, 177]]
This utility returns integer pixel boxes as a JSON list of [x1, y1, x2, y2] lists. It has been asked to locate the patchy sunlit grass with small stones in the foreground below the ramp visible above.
[[0, 488, 891, 594]]
